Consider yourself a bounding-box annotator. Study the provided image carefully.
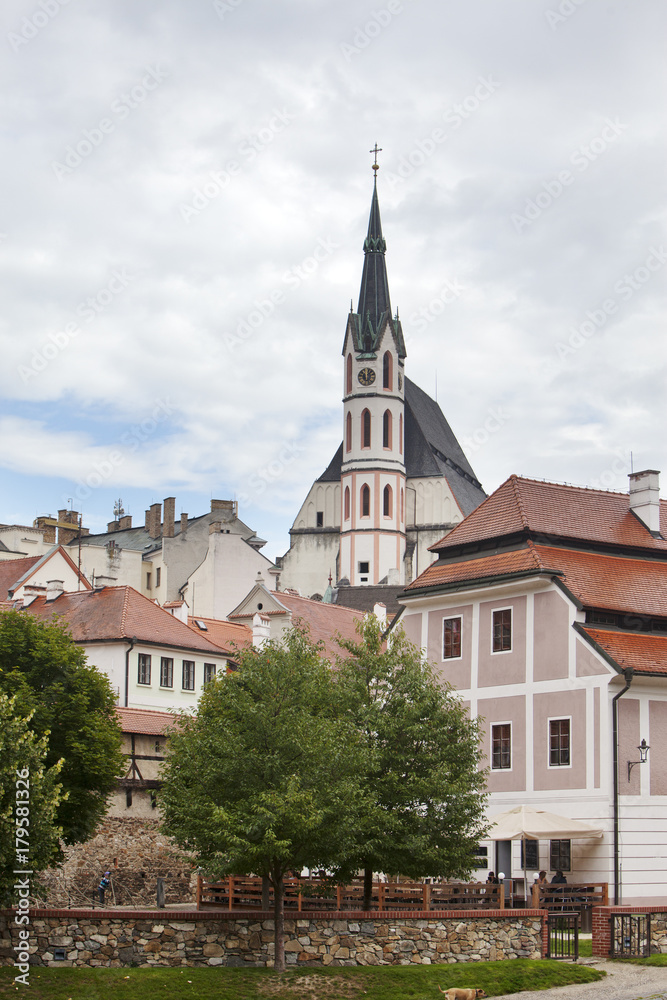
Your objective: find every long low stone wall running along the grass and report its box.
[0,910,544,967]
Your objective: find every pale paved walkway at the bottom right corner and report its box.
[515,961,667,1000]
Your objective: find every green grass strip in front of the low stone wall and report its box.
[0,956,604,1000]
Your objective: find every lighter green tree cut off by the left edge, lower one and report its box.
[0,692,63,906]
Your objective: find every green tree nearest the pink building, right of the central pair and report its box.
[336,615,486,908]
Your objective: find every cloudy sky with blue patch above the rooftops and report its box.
[0,0,667,558]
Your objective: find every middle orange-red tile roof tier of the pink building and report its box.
[406,540,667,617]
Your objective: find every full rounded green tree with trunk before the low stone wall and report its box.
[160,629,370,970]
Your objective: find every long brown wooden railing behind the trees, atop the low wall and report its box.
[197,875,505,912]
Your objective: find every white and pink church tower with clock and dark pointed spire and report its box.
[339,158,406,587]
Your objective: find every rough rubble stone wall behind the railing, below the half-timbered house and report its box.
[34,816,197,907]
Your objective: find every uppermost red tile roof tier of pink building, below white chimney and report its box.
[431,476,667,552]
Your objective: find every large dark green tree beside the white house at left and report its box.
[0,610,124,844]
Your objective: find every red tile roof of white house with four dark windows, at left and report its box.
[26,587,224,656]
